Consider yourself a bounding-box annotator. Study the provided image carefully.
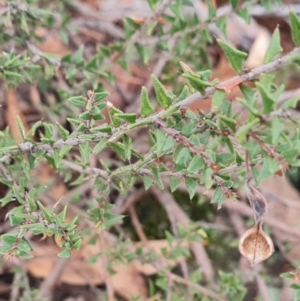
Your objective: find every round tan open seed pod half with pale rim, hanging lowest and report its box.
[239,222,274,265]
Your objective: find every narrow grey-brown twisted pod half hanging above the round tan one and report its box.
[246,181,267,223]
